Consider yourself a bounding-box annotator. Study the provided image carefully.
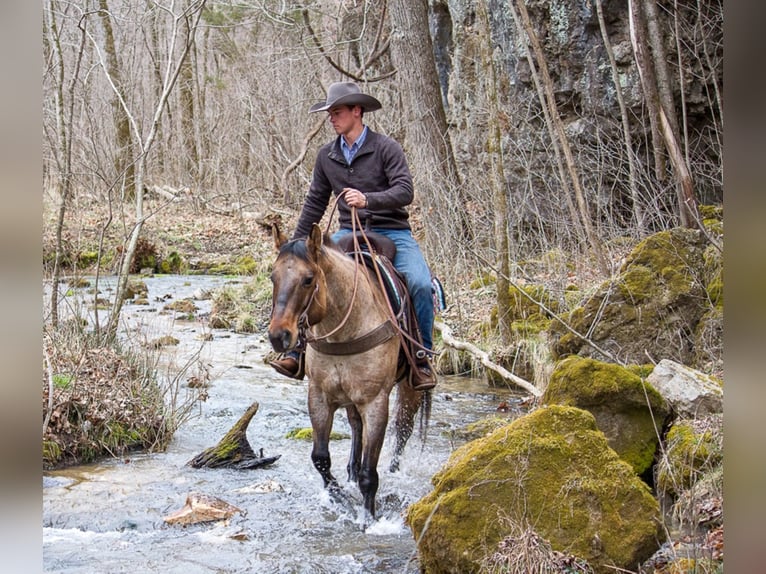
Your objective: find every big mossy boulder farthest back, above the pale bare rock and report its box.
[548,228,713,366]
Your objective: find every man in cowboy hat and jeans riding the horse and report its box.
[271,82,436,390]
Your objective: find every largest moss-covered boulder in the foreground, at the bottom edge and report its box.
[406,405,664,574]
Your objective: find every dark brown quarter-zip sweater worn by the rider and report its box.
[293,127,414,239]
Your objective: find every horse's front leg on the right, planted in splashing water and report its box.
[358,398,388,518]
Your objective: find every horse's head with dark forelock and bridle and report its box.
[269,225,327,353]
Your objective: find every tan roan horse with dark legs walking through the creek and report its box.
[268,224,431,519]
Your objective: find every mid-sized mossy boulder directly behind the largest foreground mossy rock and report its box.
[541,356,670,475]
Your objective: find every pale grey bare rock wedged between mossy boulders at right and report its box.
[647,359,723,417]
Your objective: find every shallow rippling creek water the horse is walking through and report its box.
[43,276,520,574]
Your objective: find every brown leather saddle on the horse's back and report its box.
[336,231,441,380]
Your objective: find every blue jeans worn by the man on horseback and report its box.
[332,227,434,351]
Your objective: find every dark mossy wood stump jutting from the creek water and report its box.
[186,402,282,470]
